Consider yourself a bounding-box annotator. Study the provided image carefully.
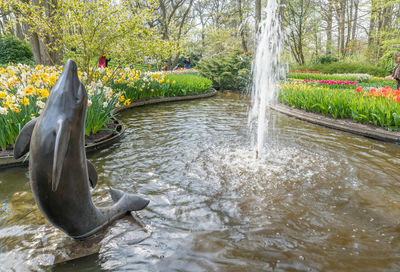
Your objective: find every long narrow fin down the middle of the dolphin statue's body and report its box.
[51,120,71,192]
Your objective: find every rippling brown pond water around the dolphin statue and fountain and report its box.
[0,94,400,271]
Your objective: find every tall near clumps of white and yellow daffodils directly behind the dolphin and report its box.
[0,65,124,150]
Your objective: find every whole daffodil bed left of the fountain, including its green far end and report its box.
[0,65,212,150]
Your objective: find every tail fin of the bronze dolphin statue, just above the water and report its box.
[110,188,150,212]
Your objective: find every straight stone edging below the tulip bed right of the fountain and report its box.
[270,104,400,144]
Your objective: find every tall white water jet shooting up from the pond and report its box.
[248,0,282,157]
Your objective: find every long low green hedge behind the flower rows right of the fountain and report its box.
[291,62,388,77]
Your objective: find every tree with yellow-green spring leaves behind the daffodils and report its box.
[3,0,175,78]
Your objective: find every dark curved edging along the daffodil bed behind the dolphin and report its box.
[0,90,217,169]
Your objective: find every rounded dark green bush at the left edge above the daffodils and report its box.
[0,36,33,64]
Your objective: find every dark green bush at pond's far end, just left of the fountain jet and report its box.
[197,51,252,91]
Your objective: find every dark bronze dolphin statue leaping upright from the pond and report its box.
[14,60,149,239]
